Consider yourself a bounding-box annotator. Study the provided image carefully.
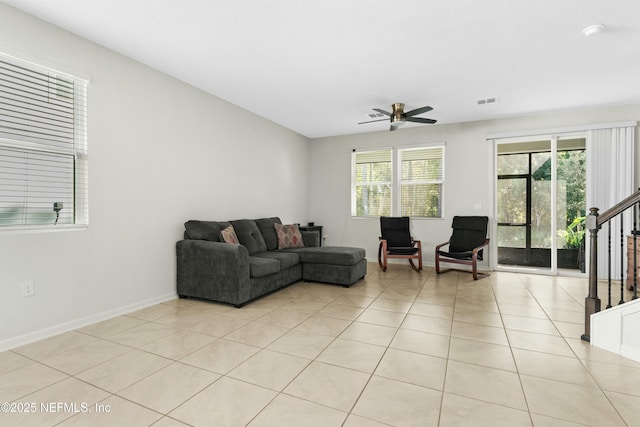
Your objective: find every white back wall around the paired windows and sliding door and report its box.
[309,105,640,268]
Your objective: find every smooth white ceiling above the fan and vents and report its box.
[5,0,640,138]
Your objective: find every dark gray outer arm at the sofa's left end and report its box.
[176,240,251,305]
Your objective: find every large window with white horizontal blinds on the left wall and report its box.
[0,55,88,229]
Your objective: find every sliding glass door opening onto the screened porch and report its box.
[496,137,586,272]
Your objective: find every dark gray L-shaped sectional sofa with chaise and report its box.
[176,217,367,307]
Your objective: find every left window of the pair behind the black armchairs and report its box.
[351,149,393,216]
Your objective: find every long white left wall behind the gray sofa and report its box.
[0,3,309,350]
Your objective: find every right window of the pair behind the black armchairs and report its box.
[399,146,444,218]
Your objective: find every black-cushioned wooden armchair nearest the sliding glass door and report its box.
[435,216,489,280]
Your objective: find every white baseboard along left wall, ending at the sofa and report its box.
[0,292,178,351]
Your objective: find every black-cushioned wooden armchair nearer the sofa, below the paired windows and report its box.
[378,216,422,272]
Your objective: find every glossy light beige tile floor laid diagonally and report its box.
[0,264,640,427]
